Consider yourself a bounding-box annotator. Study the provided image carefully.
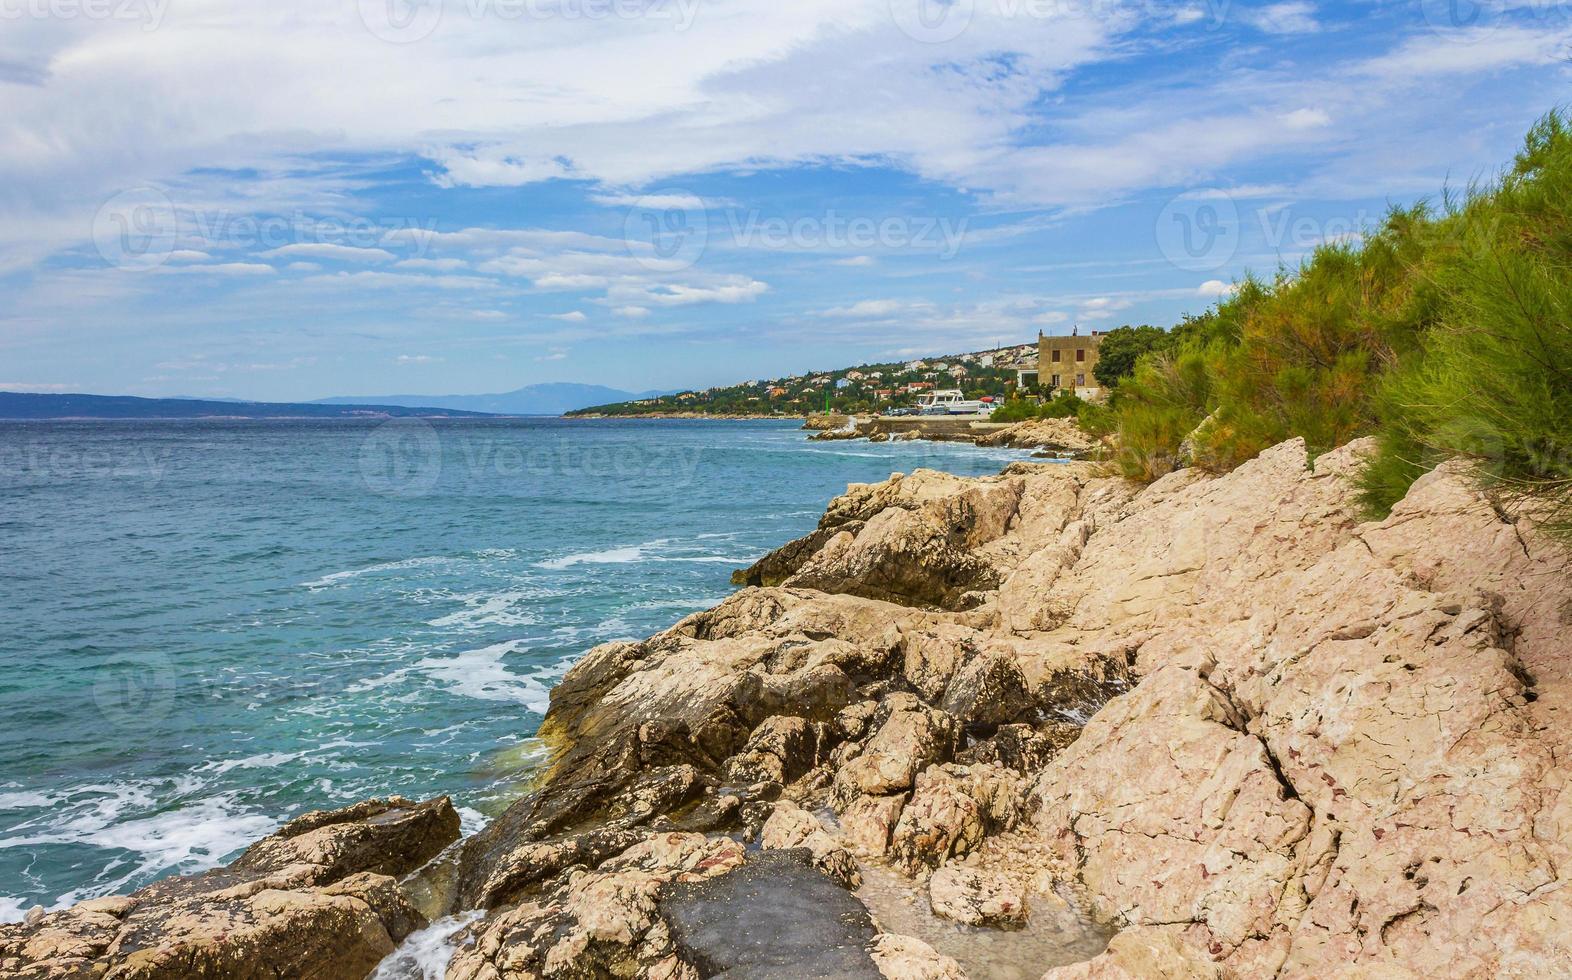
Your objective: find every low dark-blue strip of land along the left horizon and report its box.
[0,392,493,420]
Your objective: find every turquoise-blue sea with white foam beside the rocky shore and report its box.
[0,420,1023,922]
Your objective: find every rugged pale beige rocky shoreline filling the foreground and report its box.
[0,440,1572,980]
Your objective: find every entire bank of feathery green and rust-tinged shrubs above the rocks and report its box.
[1099,113,1572,547]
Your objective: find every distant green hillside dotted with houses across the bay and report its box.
[569,343,1038,417]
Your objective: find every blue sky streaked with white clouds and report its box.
[0,0,1572,400]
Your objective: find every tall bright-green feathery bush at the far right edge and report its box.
[1361,115,1572,536]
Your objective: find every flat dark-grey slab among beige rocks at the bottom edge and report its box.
[660,848,880,980]
